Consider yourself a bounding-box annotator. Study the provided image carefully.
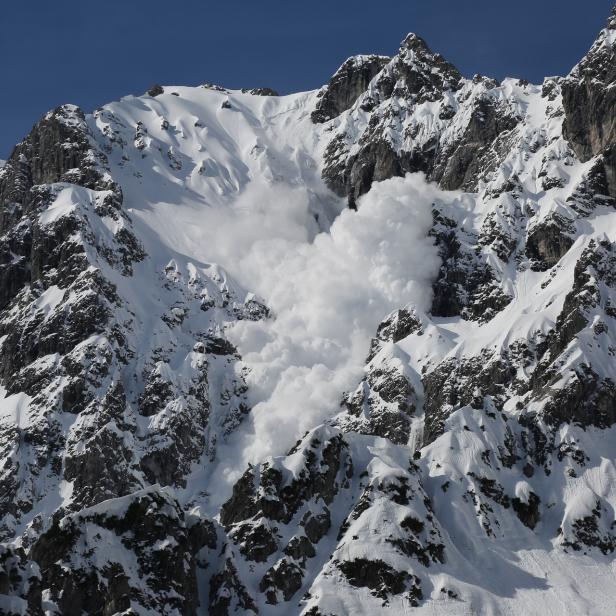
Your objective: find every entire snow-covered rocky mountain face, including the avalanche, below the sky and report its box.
[0,9,616,616]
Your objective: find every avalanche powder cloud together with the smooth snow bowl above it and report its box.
[88,87,442,496]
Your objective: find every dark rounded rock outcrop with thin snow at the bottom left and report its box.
[29,491,198,616]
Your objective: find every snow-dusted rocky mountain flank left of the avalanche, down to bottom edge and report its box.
[0,100,267,614]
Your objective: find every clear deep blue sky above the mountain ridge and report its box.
[0,0,616,158]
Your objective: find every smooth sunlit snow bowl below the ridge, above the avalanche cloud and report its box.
[94,86,340,237]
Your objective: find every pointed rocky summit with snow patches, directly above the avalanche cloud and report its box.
[319,34,520,206]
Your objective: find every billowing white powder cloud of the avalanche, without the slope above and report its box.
[210,175,443,496]
